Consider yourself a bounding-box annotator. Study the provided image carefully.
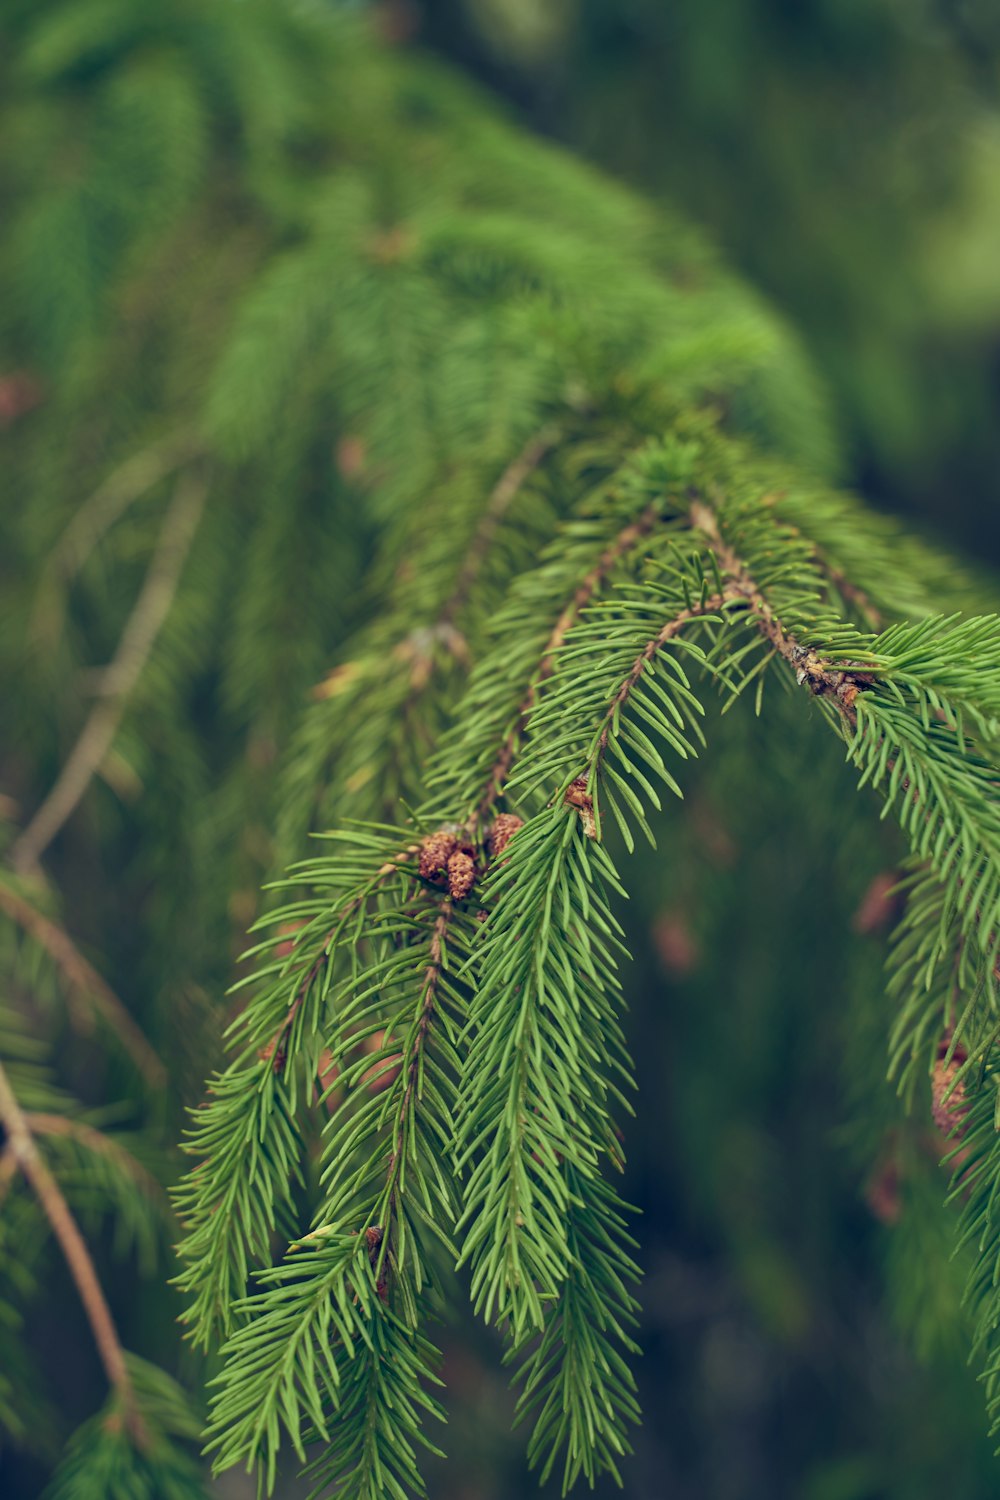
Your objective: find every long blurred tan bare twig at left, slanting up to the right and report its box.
[10,471,208,872]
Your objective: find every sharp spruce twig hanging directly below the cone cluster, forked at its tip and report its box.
[205,833,469,1497]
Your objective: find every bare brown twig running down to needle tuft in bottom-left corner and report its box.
[0,1064,145,1443]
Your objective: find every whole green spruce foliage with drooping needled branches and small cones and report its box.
[0,0,1000,1500]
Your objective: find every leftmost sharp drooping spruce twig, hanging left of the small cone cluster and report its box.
[174,827,417,1347]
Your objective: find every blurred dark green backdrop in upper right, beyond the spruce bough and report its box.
[424,0,1000,560]
